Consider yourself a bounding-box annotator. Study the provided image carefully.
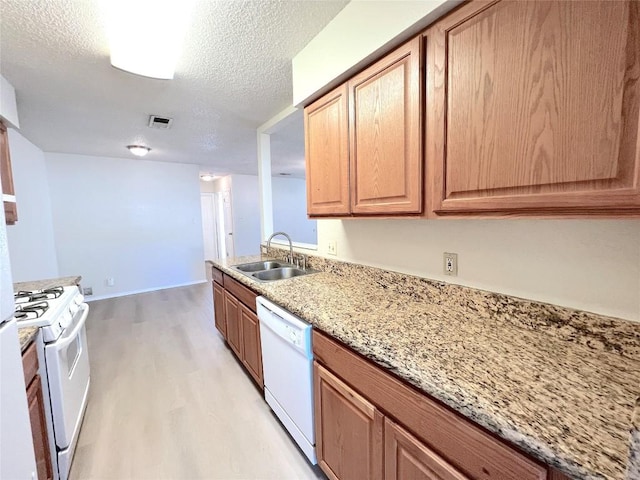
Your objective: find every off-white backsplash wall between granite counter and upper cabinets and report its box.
[318,219,640,321]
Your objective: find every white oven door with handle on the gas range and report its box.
[45,303,89,450]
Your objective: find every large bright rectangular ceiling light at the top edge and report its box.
[102,0,195,79]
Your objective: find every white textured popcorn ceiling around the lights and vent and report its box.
[0,0,347,176]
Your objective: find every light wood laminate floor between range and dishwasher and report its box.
[70,284,323,480]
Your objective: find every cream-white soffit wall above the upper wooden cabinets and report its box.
[292,0,460,105]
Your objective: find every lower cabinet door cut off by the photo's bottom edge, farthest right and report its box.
[384,418,469,480]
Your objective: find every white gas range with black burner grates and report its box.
[14,285,90,480]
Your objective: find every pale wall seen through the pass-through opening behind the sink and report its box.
[271,177,318,245]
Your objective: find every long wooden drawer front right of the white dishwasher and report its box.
[313,330,547,480]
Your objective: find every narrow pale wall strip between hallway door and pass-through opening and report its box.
[231,175,260,257]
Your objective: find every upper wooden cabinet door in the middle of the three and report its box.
[349,38,423,214]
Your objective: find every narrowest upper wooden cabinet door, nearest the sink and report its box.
[304,85,350,216]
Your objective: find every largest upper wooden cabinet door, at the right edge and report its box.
[426,1,640,214]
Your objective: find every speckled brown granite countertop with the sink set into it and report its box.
[212,255,640,479]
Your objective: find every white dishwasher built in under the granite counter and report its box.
[256,297,318,465]
